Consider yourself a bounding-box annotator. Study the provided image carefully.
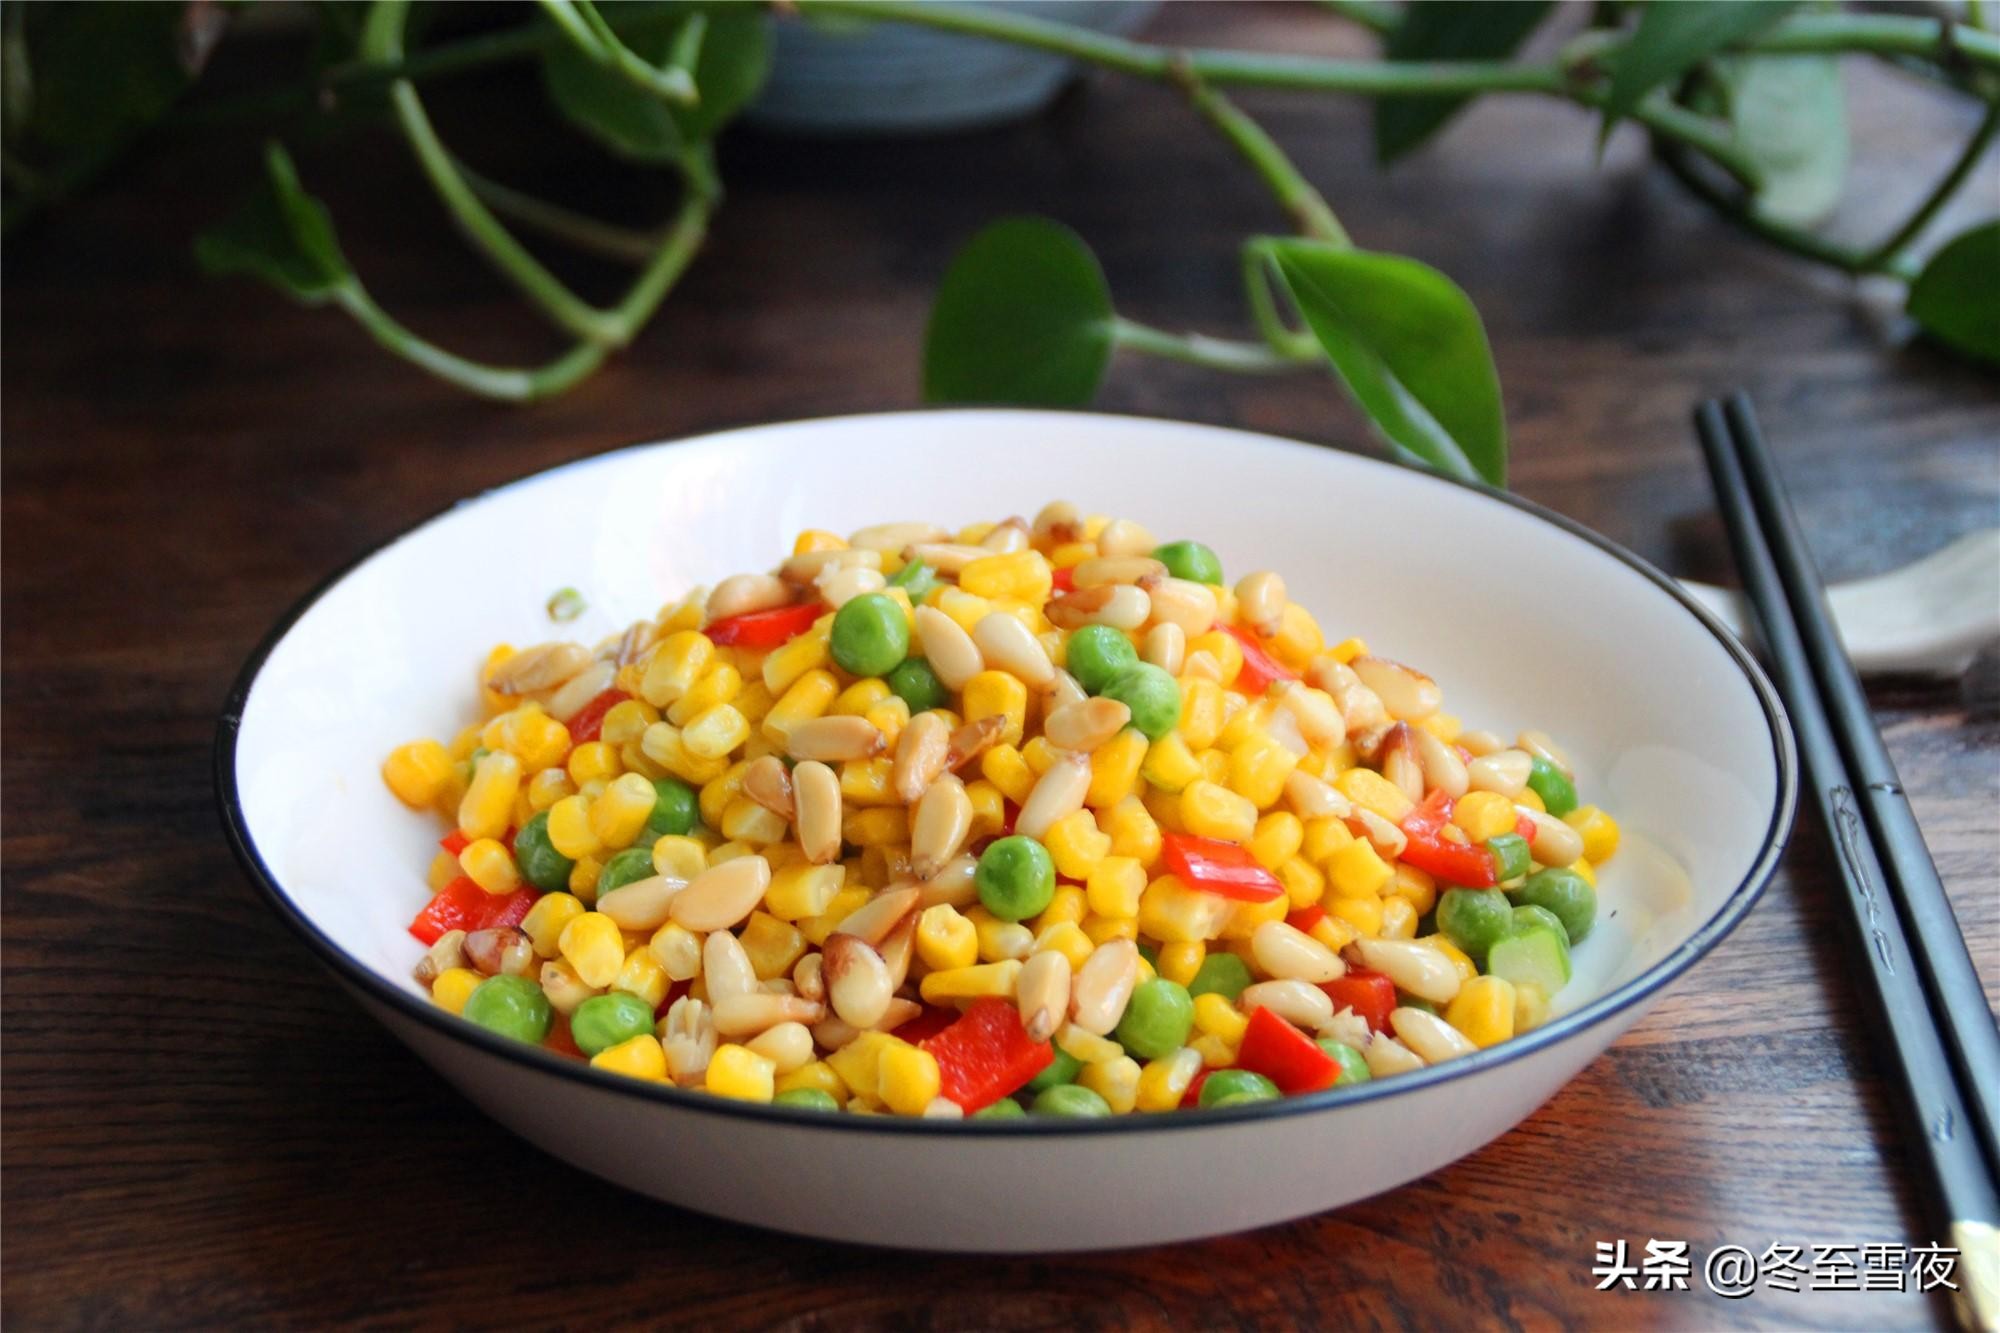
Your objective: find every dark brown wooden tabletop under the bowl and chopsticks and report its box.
[0,6,2000,1329]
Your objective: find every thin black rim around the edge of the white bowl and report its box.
[214,408,1798,1137]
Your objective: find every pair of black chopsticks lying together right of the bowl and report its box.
[1694,394,2000,1329]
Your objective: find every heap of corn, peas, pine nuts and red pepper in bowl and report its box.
[382,502,1618,1119]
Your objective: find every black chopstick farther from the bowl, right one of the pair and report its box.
[1724,392,2000,1173]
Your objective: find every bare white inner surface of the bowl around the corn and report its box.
[234,410,1786,1032]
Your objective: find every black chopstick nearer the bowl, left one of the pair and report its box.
[1694,402,2000,1327]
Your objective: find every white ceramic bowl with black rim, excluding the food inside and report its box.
[216,410,1794,1251]
